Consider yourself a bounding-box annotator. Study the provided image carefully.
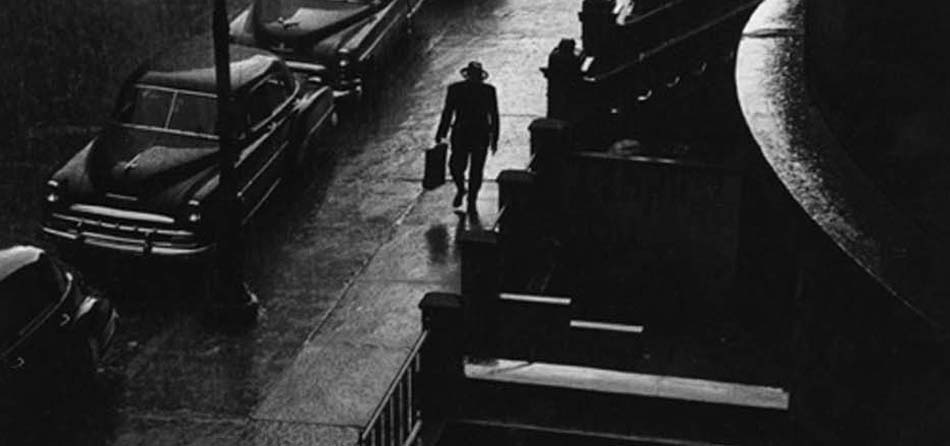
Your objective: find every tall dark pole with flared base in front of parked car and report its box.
[208,0,260,327]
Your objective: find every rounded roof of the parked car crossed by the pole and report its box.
[134,38,283,94]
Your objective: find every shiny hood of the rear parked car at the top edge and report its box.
[251,0,375,47]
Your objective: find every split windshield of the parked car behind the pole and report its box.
[119,85,218,137]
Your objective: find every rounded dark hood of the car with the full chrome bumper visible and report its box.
[55,129,218,215]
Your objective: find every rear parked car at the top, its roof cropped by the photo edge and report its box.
[231,0,423,98]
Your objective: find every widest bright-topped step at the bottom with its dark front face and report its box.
[459,359,790,445]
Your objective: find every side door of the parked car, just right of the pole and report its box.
[237,72,293,226]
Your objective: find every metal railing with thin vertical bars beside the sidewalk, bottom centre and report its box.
[359,331,428,446]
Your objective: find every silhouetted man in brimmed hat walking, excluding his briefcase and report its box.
[435,62,498,213]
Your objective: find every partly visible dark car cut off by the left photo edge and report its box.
[0,246,117,385]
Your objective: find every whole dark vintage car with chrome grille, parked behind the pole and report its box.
[43,41,336,260]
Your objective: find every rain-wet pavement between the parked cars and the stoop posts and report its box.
[0,0,580,445]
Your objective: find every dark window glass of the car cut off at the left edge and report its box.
[0,257,62,340]
